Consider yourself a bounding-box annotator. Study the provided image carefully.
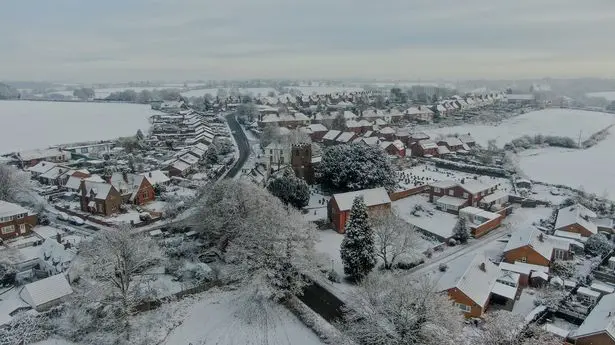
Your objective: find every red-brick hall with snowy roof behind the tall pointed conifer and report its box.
[327,187,391,234]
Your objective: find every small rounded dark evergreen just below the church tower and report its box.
[267,170,310,208]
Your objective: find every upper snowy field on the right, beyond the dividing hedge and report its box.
[426,109,615,146]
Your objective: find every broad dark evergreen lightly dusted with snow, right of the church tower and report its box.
[317,144,395,191]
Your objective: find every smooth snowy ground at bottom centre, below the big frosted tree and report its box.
[164,291,323,345]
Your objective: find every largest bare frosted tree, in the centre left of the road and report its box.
[191,180,319,299]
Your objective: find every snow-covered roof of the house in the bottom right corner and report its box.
[574,288,615,338]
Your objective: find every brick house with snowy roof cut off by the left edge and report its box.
[0,200,38,240]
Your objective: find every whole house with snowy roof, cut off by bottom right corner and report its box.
[570,294,615,345]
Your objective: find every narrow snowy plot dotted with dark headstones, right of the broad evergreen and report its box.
[398,164,513,193]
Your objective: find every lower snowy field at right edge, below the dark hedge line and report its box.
[519,129,615,200]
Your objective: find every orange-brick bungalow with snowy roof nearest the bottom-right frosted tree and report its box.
[437,254,502,318]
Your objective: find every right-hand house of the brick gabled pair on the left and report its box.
[109,172,156,205]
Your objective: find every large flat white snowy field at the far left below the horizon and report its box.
[0,101,156,153]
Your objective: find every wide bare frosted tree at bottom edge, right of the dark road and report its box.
[341,272,463,345]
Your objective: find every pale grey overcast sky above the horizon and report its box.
[0,0,615,82]
